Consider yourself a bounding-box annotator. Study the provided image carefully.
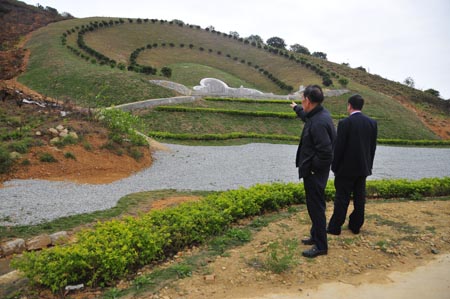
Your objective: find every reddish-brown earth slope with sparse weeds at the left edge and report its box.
[0,0,152,188]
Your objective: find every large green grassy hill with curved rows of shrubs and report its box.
[15,18,448,139]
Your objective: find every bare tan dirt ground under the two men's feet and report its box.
[151,201,450,299]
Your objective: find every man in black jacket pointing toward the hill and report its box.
[291,85,336,257]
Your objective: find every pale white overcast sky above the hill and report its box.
[25,0,450,99]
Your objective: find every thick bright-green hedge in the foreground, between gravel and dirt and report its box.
[12,177,450,292]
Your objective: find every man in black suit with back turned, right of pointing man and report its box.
[327,95,378,235]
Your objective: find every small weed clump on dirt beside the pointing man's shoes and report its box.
[264,239,298,274]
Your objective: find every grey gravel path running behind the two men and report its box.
[0,143,450,225]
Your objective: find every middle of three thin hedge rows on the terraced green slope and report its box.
[155,106,345,119]
